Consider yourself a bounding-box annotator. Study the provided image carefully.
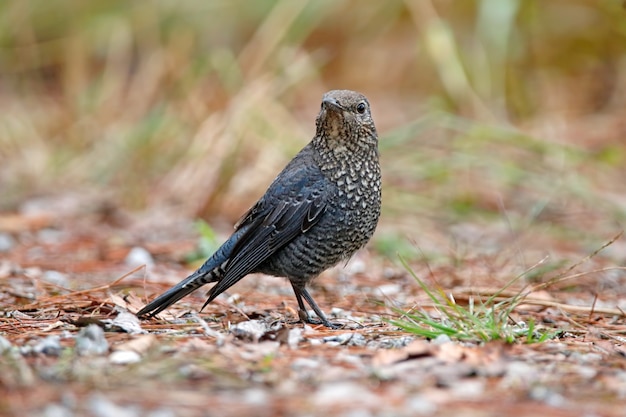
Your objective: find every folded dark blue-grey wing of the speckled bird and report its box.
[200,189,327,305]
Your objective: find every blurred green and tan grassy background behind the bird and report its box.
[0,0,626,270]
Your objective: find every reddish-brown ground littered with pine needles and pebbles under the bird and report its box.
[0,198,626,417]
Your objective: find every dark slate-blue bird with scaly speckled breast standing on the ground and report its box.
[137,90,382,329]
